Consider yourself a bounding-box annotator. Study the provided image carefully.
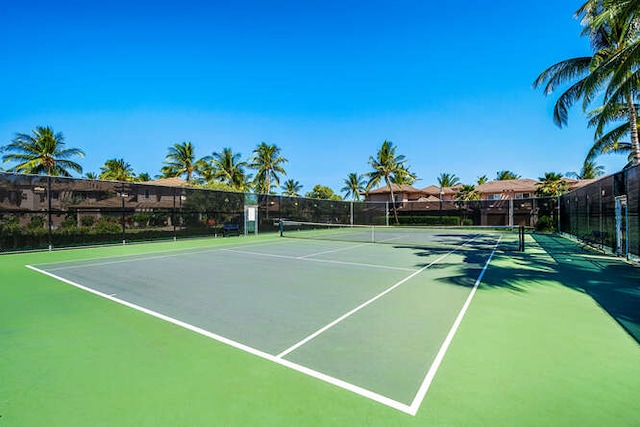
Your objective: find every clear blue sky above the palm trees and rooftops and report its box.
[0,0,625,192]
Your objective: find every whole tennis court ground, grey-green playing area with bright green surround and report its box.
[0,234,640,427]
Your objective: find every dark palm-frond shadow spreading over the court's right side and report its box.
[402,234,640,343]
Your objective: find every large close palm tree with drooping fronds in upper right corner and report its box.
[533,0,640,164]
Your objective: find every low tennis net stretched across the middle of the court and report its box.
[280,221,525,251]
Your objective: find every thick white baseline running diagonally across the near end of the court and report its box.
[26,265,410,414]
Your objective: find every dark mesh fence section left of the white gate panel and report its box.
[0,173,244,251]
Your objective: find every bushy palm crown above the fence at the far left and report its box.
[2,126,84,176]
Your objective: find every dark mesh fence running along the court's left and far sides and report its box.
[0,173,557,251]
